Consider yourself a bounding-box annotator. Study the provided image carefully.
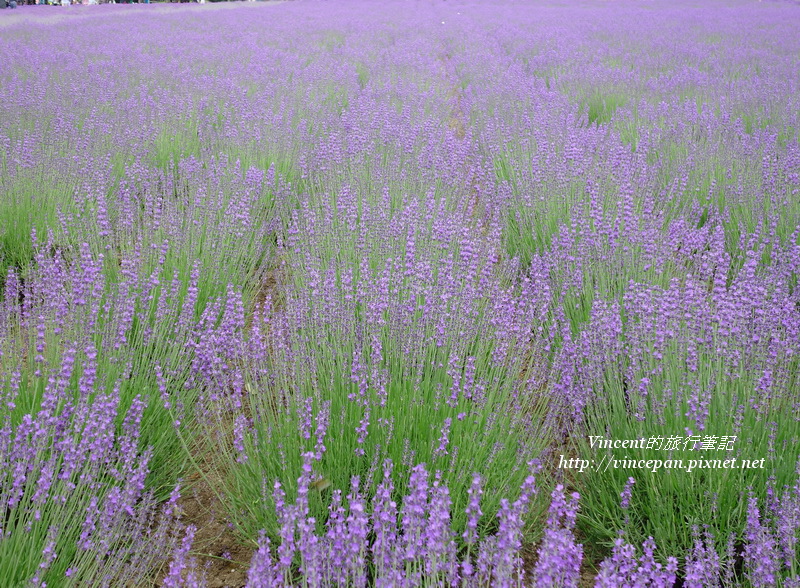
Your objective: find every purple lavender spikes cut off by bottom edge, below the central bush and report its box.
[247,460,536,587]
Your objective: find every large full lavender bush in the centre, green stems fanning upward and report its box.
[218,194,551,538]
